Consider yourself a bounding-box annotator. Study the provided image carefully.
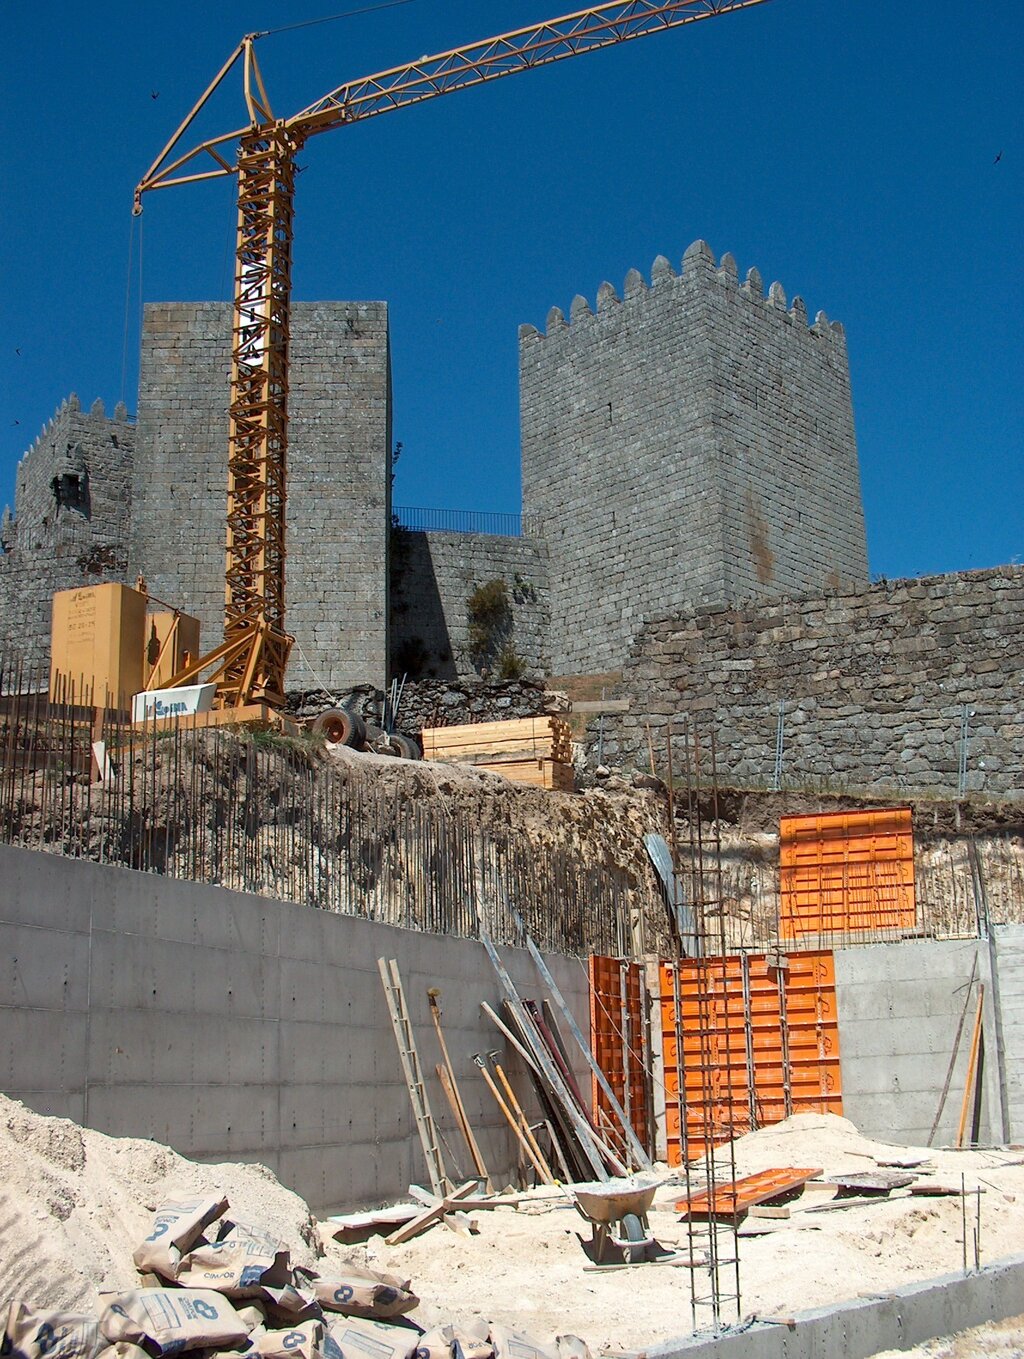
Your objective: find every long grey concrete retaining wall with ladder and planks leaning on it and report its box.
[0,845,589,1212]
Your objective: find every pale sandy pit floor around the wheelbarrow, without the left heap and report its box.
[361,1114,1024,1352]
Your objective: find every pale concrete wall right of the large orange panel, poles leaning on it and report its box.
[835,939,1001,1146]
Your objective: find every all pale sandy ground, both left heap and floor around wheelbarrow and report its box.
[7,1097,1024,1359]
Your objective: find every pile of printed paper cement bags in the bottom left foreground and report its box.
[0,1197,590,1359]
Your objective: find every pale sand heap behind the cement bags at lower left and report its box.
[0,1095,322,1311]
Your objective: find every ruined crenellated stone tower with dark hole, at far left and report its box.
[0,395,135,667]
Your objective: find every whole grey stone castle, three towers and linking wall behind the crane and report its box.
[0,242,868,690]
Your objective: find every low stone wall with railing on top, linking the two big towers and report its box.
[390,529,549,680]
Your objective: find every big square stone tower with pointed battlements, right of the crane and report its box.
[519,241,868,674]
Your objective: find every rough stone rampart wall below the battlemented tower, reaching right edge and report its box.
[604,567,1024,798]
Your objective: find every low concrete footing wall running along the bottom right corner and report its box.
[643,1256,1024,1359]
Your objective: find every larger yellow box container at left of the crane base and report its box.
[50,583,147,708]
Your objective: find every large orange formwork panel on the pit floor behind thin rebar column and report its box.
[660,950,843,1165]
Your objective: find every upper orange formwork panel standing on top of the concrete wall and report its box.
[779,807,917,939]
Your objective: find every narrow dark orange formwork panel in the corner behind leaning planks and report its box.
[587,954,650,1152]
